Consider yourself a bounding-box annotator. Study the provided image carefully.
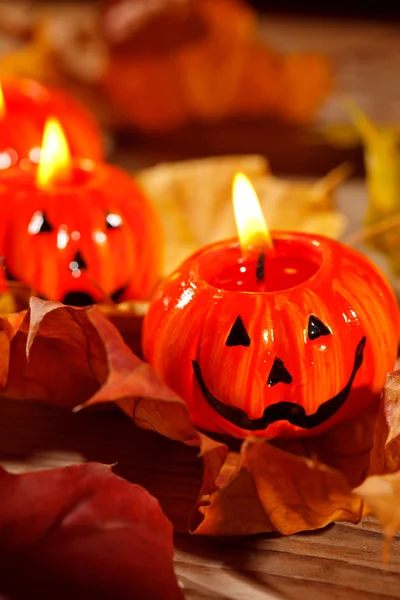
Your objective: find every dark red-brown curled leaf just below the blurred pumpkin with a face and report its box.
[3,298,107,408]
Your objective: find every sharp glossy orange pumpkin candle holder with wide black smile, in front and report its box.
[143,233,399,437]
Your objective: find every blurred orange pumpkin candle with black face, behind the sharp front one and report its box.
[0,159,163,303]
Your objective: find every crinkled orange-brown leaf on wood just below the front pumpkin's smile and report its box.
[191,443,361,535]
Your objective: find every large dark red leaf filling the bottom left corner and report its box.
[0,463,183,600]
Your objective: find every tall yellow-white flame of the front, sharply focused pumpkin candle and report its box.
[233,173,272,254]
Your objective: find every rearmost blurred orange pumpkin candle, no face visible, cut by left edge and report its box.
[0,79,104,169]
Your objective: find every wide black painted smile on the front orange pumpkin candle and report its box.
[192,337,367,431]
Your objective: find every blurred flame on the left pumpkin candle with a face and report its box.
[36,118,71,188]
